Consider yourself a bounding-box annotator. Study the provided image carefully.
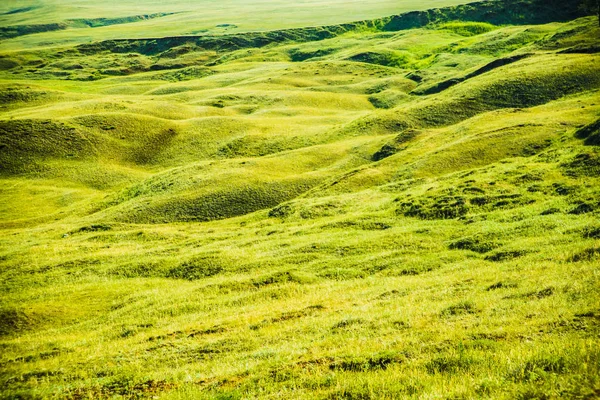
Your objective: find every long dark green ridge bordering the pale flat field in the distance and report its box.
[77,0,590,54]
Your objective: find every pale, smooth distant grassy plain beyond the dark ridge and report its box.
[0,0,469,51]
